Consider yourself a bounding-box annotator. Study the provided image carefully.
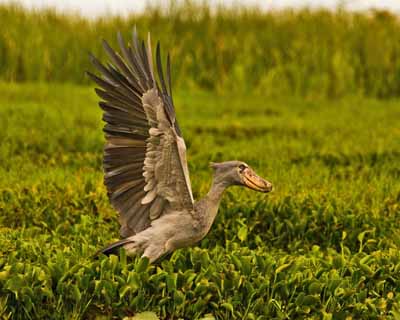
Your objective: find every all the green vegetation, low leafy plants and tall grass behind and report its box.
[0,3,400,320]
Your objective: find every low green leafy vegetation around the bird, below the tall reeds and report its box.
[0,83,400,319]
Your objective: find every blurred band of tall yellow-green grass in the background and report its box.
[0,2,400,98]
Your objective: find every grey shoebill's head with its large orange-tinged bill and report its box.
[210,161,272,193]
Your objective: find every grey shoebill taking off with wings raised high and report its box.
[87,27,272,263]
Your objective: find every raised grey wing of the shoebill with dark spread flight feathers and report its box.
[88,30,193,237]
